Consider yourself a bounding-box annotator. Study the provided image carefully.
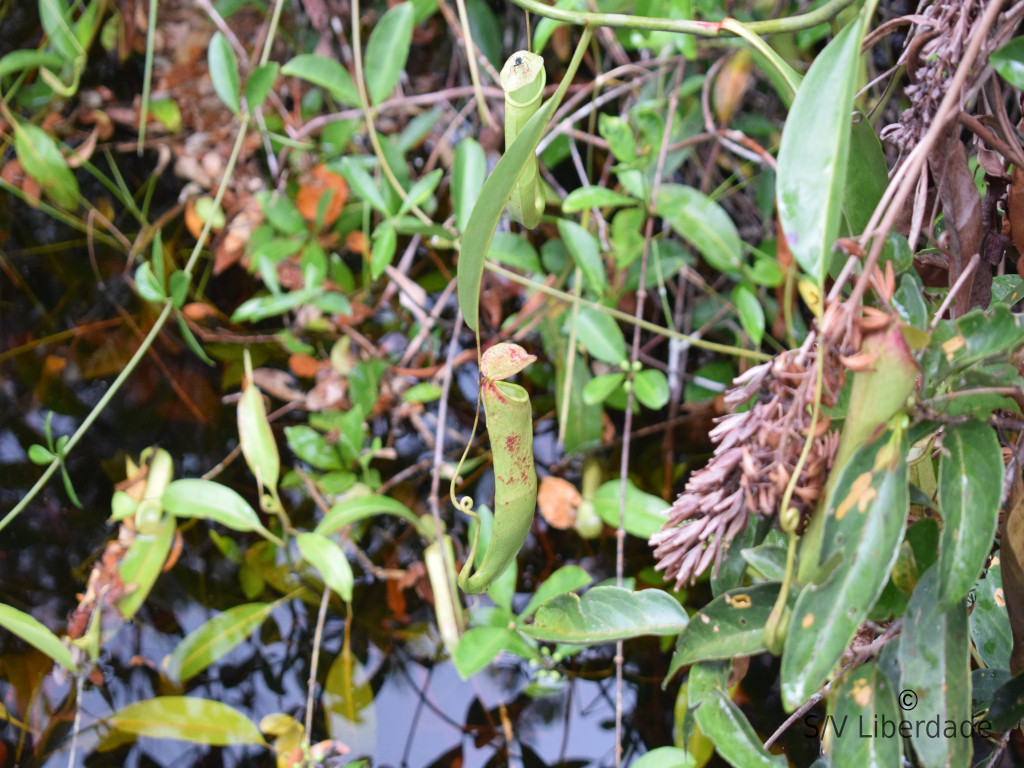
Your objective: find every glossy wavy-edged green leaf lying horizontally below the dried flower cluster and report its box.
[520,587,687,645]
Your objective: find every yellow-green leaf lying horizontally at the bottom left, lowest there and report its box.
[106,696,266,746]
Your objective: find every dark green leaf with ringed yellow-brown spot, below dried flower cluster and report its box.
[668,584,779,679]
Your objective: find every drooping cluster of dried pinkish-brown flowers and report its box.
[650,335,844,590]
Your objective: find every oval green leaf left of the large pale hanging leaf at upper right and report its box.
[656,184,742,275]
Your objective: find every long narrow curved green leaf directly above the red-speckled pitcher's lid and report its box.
[458,90,558,331]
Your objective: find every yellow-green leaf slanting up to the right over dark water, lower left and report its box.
[164,603,276,683]
